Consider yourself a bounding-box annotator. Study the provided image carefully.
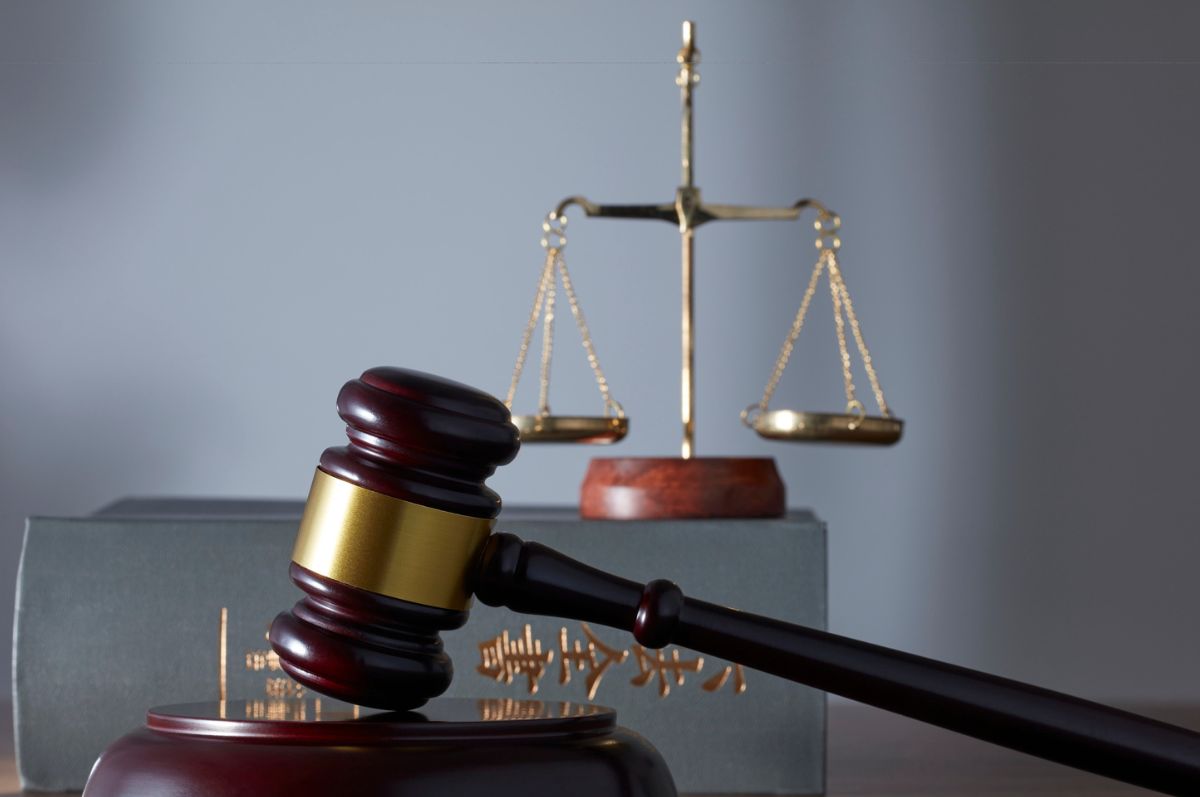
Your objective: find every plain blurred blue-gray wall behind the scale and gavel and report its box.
[0,0,1200,700]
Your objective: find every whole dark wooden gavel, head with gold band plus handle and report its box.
[270,367,1200,795]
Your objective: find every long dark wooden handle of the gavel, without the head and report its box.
[472,534,1200,795]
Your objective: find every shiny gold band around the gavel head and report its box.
[292,468,494,611]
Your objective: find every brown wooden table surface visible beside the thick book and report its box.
[0,703,1200,797]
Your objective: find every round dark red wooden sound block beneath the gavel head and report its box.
[84,697,676,797]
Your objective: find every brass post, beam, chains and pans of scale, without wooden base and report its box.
[505,22,904,459]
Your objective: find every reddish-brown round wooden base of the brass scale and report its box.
[580,456,786,520]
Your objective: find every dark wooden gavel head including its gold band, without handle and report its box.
[270,367,518,709]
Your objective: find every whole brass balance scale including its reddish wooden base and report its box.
[505,22,904,520]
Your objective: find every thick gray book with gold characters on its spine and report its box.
[13,499,826,795]
